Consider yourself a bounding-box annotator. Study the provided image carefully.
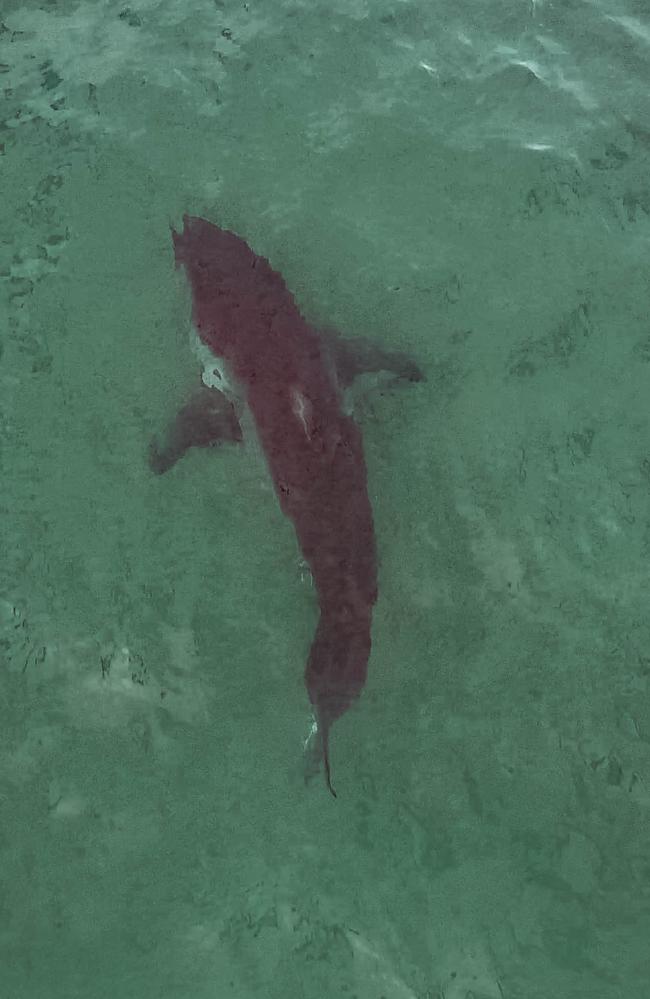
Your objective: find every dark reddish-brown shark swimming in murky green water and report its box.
[149,215,424,797]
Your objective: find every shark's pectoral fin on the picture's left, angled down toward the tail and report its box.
[149,386,242,475]
